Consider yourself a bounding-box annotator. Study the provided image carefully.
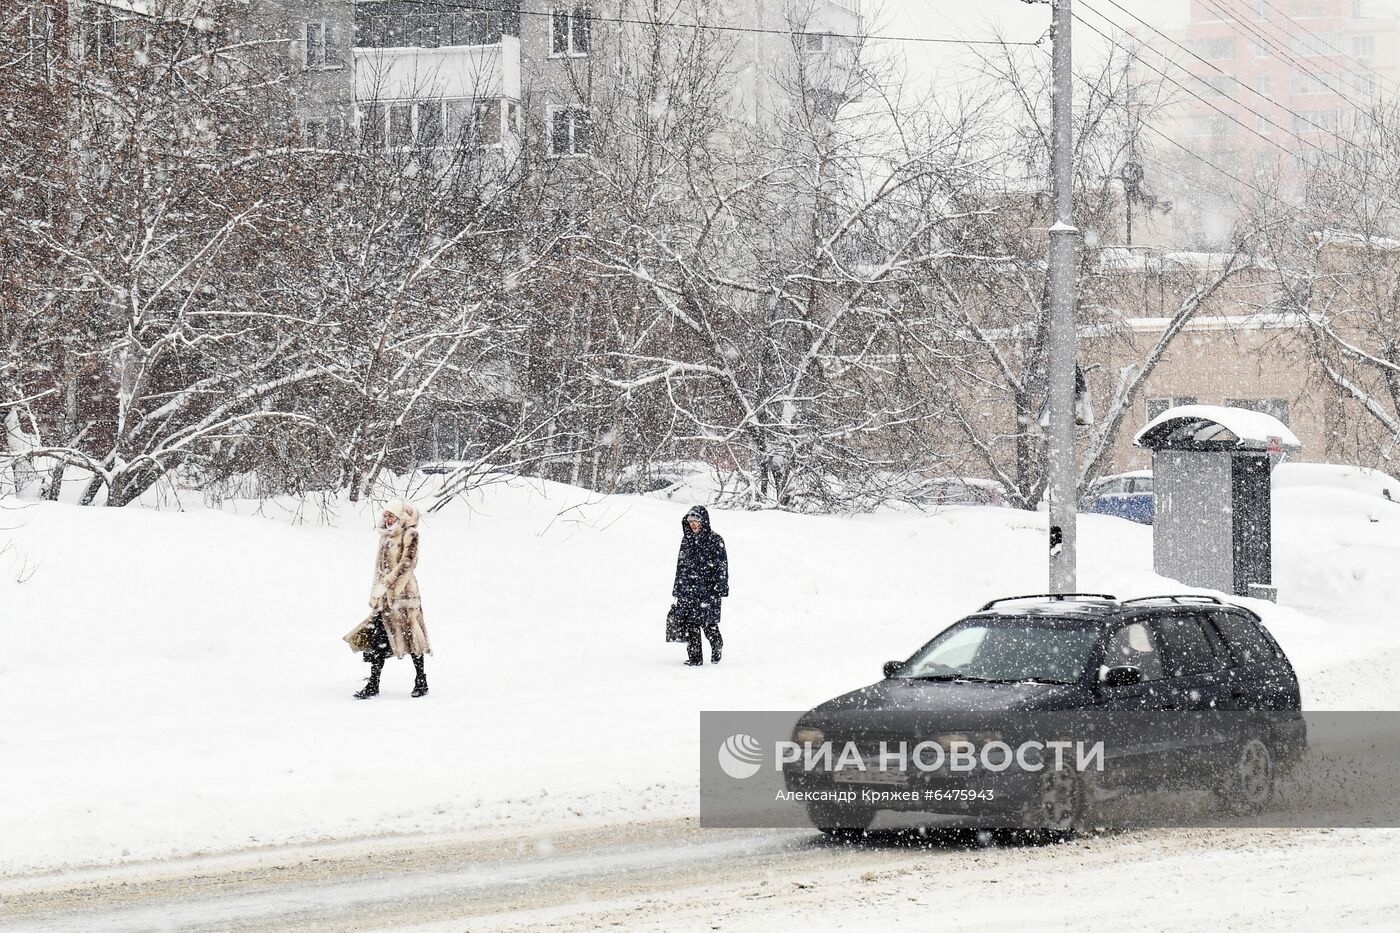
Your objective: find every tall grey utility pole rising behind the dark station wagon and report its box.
[1046,0,1079,593]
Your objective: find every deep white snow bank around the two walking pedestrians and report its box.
[0,483,1400,873]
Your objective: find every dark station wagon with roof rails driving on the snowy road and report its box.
[784,594,1306,832]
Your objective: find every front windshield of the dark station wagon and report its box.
[895,616,1098,684]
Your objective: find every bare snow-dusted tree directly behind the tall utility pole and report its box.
[937,36,1252,507]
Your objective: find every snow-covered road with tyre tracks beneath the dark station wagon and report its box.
[0,821,1400,933]
